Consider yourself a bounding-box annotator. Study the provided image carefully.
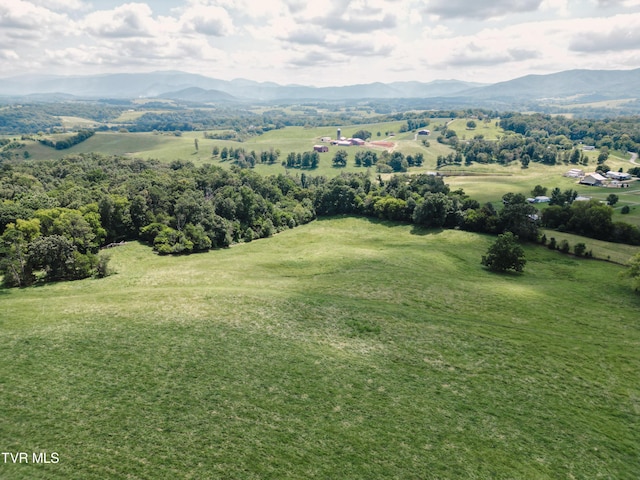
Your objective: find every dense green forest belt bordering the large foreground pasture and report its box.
[0,150,640,286]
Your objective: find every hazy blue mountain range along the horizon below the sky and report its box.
[0,68,640,103]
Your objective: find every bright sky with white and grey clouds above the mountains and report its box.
[0,0,640,87]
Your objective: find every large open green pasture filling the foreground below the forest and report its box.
[0,217,640,480]
